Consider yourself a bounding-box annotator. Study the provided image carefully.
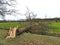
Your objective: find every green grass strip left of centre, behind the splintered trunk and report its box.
[0,22,28,28]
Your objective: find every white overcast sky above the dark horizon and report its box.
[0,0,60,19]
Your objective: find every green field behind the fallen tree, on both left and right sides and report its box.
[0,22,60,33]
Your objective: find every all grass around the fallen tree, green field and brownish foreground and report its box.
[0,22,60,45]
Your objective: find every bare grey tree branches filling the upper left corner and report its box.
[0,0,16,20]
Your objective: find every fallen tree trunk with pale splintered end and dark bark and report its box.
[6,26,31,39]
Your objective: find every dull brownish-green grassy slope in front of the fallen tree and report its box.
[0,30,60,45]
